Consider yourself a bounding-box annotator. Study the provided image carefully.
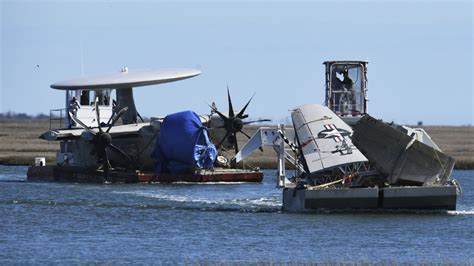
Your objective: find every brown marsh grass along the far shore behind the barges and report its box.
[0,119,474,169]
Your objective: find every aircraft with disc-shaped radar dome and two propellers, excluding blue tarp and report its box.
[40,67,268,179]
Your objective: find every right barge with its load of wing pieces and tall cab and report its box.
[236,61,459,212]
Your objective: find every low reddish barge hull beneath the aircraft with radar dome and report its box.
[27,166,263,183]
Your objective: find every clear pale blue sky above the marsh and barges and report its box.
[0,0,474,125]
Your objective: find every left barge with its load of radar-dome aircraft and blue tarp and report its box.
[27,67,263,183]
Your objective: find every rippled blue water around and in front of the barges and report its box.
[0,166,474,264]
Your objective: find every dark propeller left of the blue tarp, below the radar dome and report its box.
[69,97,131,180]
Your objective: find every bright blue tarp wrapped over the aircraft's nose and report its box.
[153,111,217,174]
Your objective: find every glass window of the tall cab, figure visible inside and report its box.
[330,64,364,116]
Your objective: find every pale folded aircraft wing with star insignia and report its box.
[291,104,367,173]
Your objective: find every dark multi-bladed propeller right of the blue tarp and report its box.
[209,86,271,154]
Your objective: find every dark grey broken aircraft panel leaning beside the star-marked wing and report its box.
[352,115,454,185]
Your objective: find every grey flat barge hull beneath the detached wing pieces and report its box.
[283,186,457,212]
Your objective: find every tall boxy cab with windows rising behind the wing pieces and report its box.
[323,61,368,125]
